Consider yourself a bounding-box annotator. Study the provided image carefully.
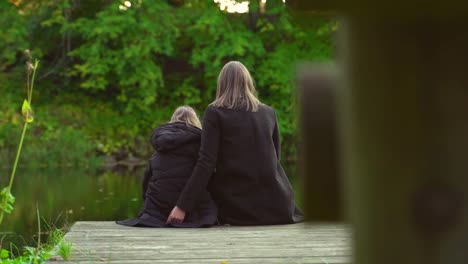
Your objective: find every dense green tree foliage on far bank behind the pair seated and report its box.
[0,0,338,163]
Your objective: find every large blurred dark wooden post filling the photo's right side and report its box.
[296,0,468,264]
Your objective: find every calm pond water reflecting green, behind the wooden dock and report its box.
[0,164,300,248]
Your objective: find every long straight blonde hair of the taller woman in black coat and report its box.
[211,61,260,112]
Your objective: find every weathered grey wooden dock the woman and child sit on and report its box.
[52,222,351,264]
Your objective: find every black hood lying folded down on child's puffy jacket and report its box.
[151,122,201,152]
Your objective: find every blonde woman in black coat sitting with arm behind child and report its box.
[167,61,303,225]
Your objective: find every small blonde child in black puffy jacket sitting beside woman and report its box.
[117,106,217,227]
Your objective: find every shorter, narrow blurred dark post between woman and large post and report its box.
[297,65,342,222]
